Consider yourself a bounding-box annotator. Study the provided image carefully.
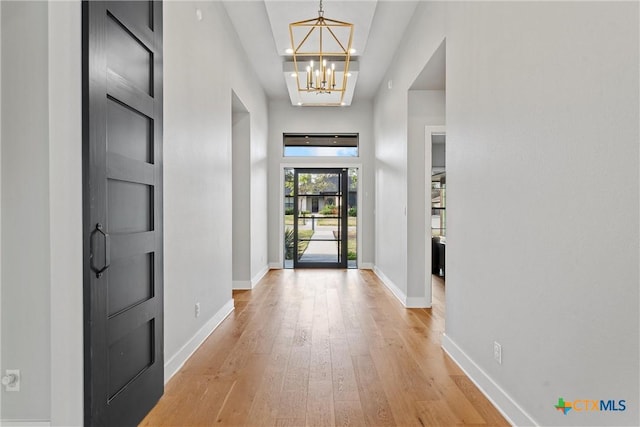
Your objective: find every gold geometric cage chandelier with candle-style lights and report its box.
[289,0,353,105]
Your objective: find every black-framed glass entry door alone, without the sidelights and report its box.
[293,168,349,268]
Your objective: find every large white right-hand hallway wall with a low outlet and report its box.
[375,2,640,425]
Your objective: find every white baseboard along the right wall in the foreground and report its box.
[442,334,539,426]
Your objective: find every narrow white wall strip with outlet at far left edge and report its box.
[1,2,51,420]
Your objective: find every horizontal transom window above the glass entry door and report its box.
[283,133,358,157]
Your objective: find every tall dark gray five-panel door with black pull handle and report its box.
[83,1,164,426]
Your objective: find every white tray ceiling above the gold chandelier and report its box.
[223,0,430,106]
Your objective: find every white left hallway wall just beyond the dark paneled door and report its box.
[164,1,268,375]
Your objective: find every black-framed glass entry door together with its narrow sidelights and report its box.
[284,167,358,268]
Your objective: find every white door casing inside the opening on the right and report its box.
[424,126,447,307]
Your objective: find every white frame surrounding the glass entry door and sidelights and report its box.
[278,162,362,269]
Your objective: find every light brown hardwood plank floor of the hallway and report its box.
[141,270,508,427]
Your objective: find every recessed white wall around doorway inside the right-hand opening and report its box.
[406,90,445,307]
